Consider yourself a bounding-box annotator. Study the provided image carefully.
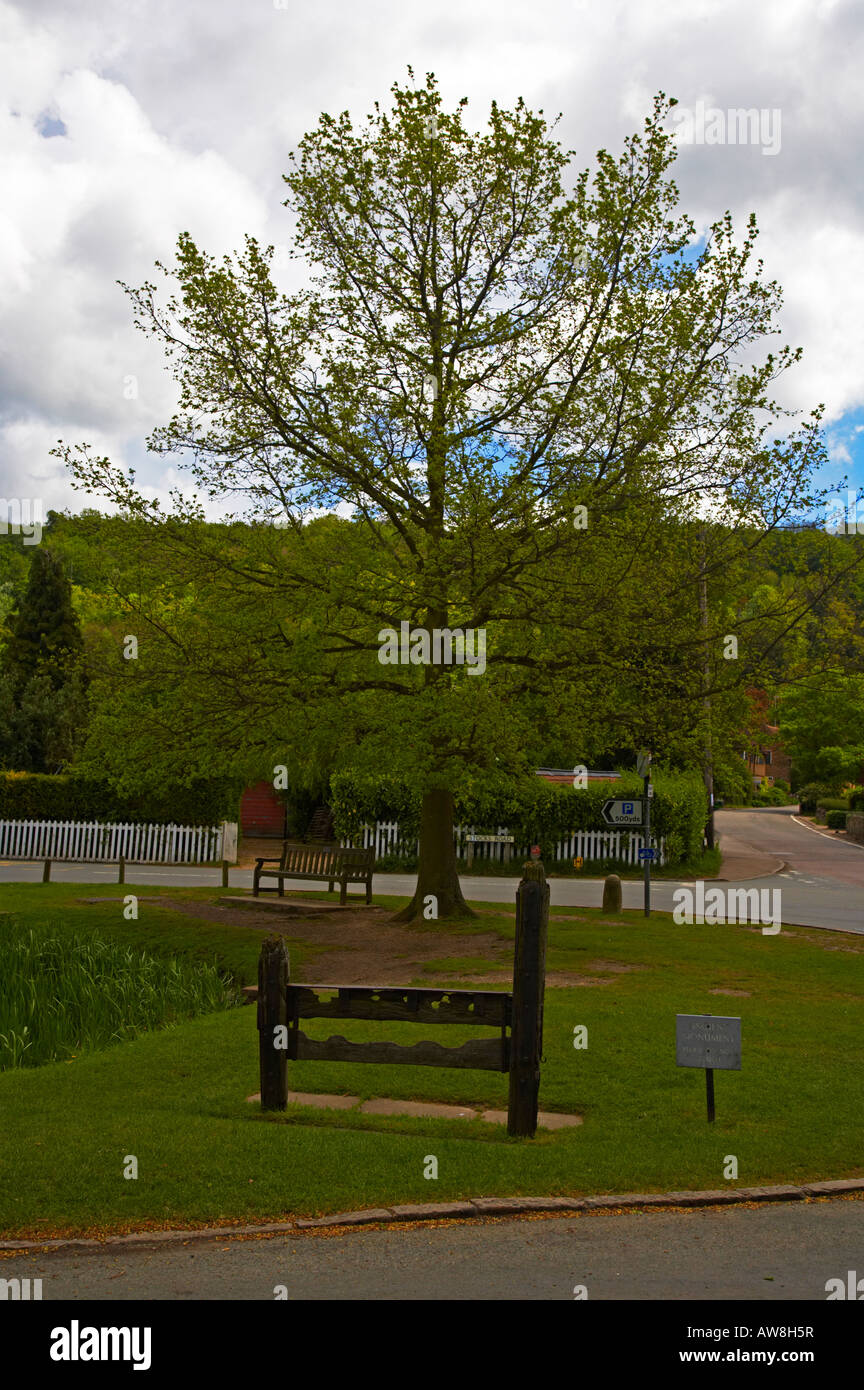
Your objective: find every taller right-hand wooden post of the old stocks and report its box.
[507,860,549,1138]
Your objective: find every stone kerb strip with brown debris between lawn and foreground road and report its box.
[0,1177,864,1254]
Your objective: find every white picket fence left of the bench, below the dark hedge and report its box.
[0,820,231,865]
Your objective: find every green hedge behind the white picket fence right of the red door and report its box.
[331,770,708,863]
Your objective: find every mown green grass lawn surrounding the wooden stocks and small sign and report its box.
[0,884,864,1236]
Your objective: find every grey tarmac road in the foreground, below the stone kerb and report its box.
[6,1200,864,1301]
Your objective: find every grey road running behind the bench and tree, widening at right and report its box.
[0,808,864,934]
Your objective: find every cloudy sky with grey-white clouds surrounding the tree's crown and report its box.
[0,0,864,522]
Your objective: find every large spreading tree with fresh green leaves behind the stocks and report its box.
[58,76,838,919]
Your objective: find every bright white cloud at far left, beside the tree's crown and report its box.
[0,10,267,505]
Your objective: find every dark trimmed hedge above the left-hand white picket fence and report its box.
[0,773,242,826]
